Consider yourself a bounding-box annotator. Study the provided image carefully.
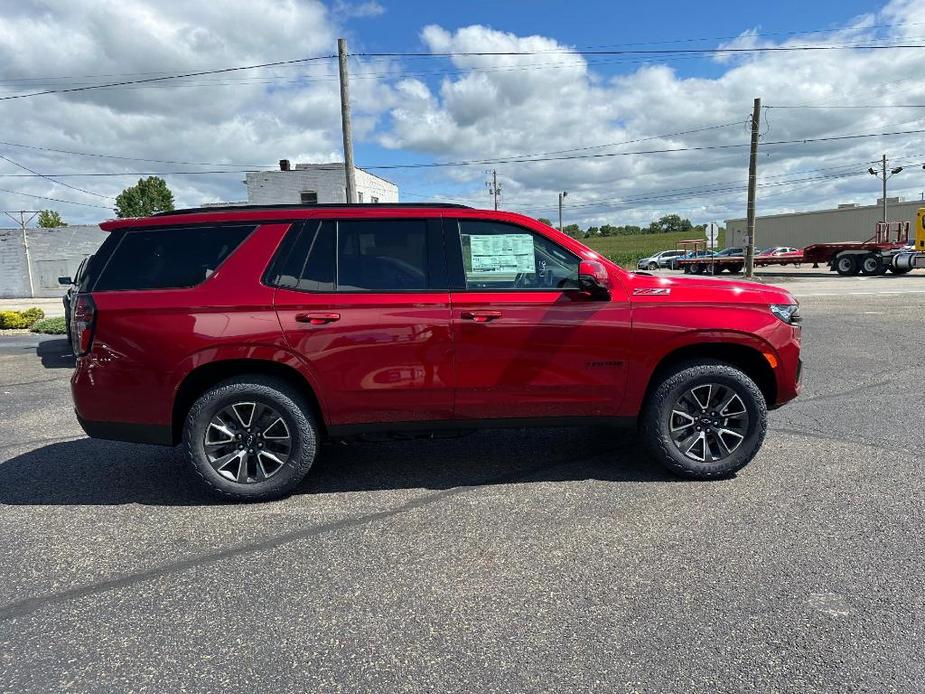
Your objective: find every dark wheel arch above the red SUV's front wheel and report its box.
[642,342,777,409]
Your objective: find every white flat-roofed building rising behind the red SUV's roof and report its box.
[244,159,398,205]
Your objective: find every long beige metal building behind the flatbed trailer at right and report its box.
[726,198,925,248]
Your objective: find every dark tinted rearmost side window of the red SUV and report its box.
[93,224,256,291]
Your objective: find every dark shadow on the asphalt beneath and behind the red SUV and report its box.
[0,428,680,506]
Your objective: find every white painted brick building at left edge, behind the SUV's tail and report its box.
[0,224,106,298]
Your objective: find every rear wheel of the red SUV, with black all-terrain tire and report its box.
[183,375,318,501]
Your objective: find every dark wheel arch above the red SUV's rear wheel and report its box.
[171,358,326,444]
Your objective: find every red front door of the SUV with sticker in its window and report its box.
[445,219,630,419]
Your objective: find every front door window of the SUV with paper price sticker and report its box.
[459,220,580,290]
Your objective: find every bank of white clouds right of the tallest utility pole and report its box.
[380,1,925,224]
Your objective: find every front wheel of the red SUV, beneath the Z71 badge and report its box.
[640,360,768,480]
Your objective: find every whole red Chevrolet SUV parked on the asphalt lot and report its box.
[71,205,801,500]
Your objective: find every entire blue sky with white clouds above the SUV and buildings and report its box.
[0,0,925,226]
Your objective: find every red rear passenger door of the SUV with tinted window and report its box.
[268,218,453,426]
